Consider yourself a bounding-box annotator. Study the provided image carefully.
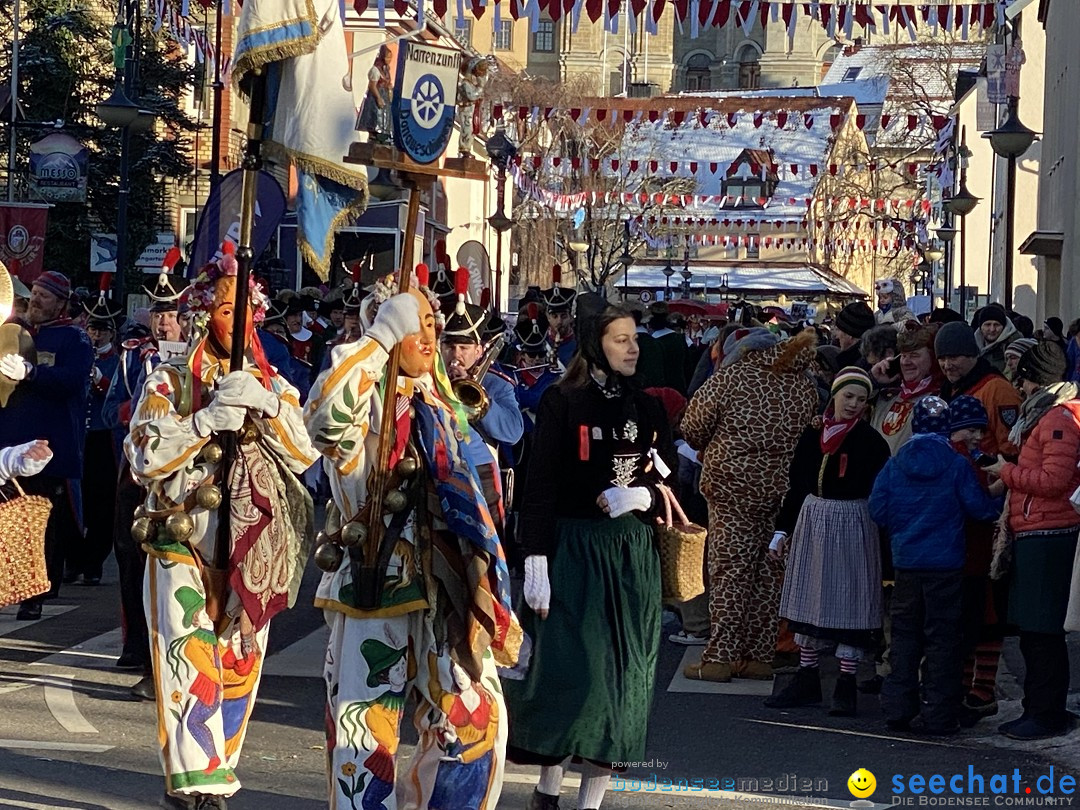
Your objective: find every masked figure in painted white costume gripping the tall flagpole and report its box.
[124,255,315,810]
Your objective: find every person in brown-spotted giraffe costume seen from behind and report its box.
[681,329,818,680]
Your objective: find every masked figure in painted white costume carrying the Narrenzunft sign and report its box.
[305,266,519,810]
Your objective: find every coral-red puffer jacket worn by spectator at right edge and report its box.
[1001,400,1080,531]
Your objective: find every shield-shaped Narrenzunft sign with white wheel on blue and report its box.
[390,42,461,163]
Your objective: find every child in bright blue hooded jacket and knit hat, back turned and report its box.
[869,396,1003,734]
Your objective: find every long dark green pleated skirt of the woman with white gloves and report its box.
[503,515,661,762]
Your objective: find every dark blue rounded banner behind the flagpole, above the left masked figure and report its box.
[187,168,285,279]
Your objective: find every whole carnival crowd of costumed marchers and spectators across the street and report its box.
[6,260,1080,810]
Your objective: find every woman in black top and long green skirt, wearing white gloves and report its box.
[504,294,675,810]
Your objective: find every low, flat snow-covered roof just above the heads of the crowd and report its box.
[626,262,868,298]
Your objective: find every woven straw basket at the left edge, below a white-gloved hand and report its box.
[0,478,53,606]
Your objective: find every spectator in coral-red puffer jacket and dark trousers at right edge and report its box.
[987,340,1080,740]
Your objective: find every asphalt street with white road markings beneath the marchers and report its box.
[0,557,1080,810]
